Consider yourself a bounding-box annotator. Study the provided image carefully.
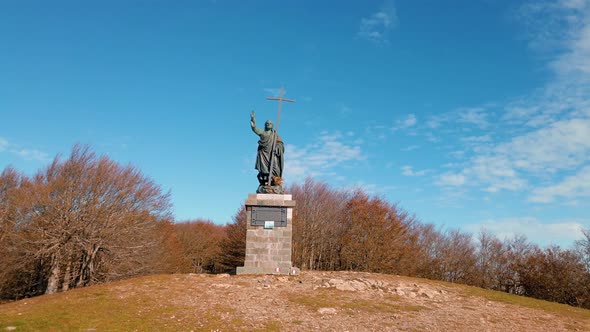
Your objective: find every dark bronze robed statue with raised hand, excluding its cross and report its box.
[250,112,285,194]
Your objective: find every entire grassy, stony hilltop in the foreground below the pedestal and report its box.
[0,272,590,331]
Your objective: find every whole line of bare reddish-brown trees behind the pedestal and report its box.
[0,145,590,308]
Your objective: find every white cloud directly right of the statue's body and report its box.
[284,132,366,181]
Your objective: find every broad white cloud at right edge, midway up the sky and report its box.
[439,115,590,195]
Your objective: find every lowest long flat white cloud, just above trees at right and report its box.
[463,217,590,246]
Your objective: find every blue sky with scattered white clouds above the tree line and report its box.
[0,0,590,246]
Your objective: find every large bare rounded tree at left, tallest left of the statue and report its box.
[13,145,170,294]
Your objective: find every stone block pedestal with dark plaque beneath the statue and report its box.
[236,194,299,274]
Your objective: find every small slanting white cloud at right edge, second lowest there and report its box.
[529,166,590,203]
